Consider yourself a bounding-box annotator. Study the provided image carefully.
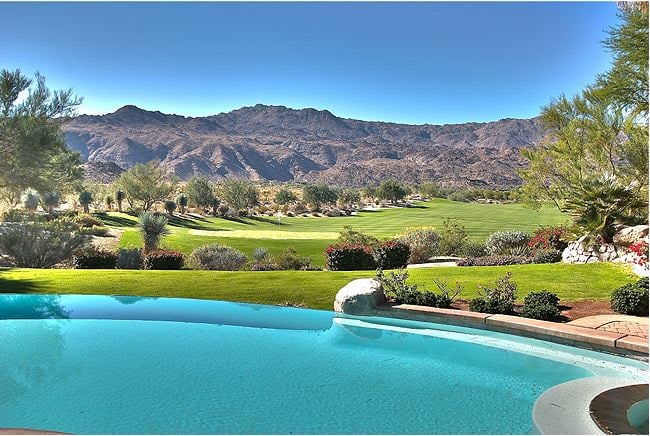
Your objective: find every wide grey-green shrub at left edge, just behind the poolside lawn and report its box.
[0,220,87,268]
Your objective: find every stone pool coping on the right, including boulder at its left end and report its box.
[334,279,648,361]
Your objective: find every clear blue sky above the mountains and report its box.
[0,3,617,124]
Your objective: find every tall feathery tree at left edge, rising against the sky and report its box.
[0,69,83,206]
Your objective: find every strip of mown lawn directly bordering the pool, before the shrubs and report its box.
[0,264,635,310]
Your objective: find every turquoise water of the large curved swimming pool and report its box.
[0,295,646,434]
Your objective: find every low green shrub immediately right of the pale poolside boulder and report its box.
[375,268,462,308]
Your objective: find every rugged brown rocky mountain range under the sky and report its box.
[64,105,542,188]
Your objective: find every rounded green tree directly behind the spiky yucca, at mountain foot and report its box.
[116,162,176,211]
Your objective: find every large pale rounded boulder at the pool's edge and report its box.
[334,279,386,315]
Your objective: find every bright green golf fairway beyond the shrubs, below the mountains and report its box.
[112,199,567,265]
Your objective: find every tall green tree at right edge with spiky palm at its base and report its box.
[519,7,648,241]
